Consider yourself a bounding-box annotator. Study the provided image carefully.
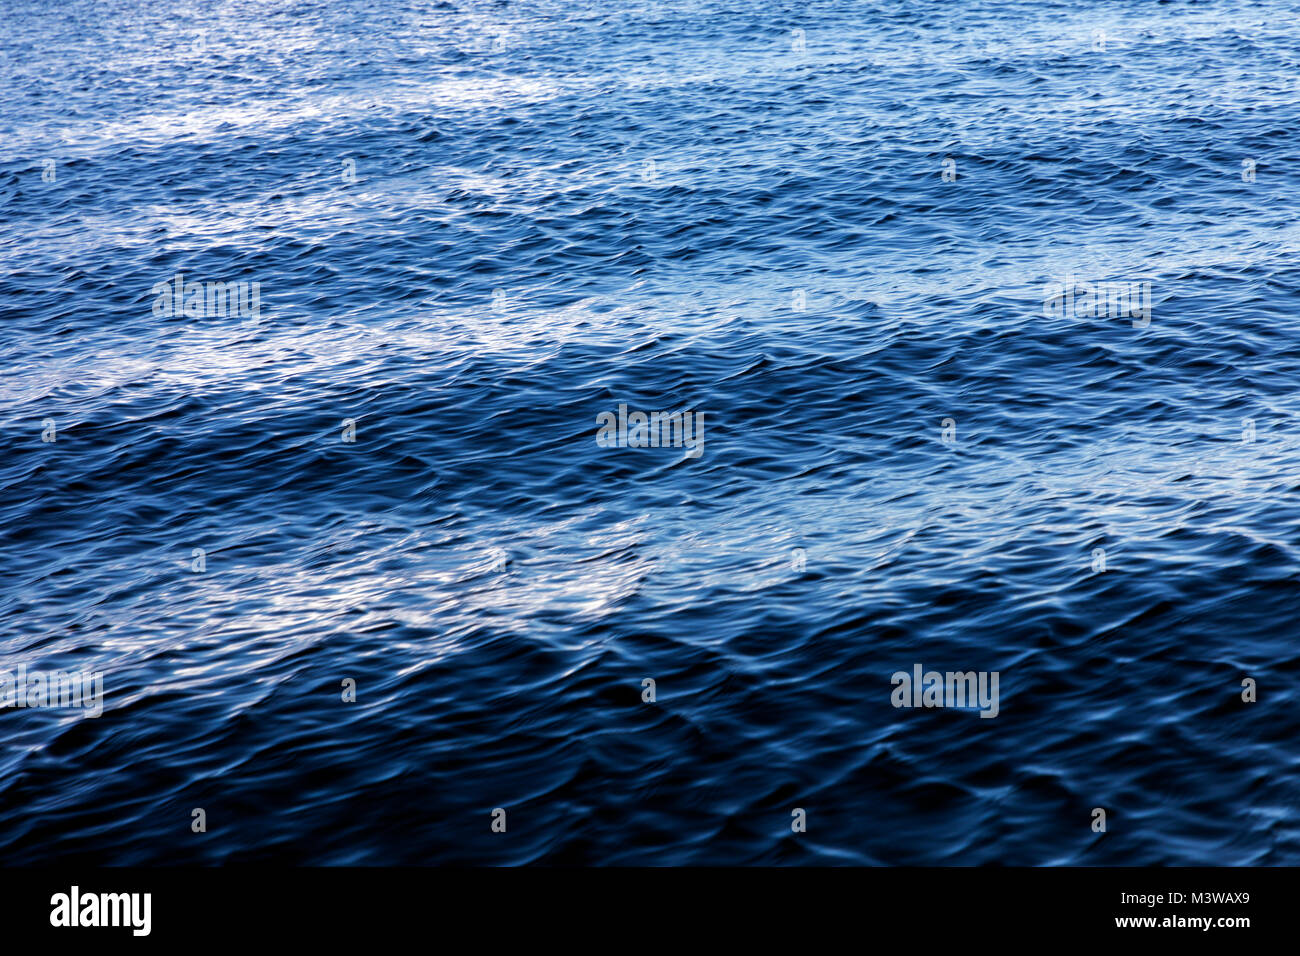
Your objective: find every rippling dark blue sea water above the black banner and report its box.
[0,0,1300,865]
